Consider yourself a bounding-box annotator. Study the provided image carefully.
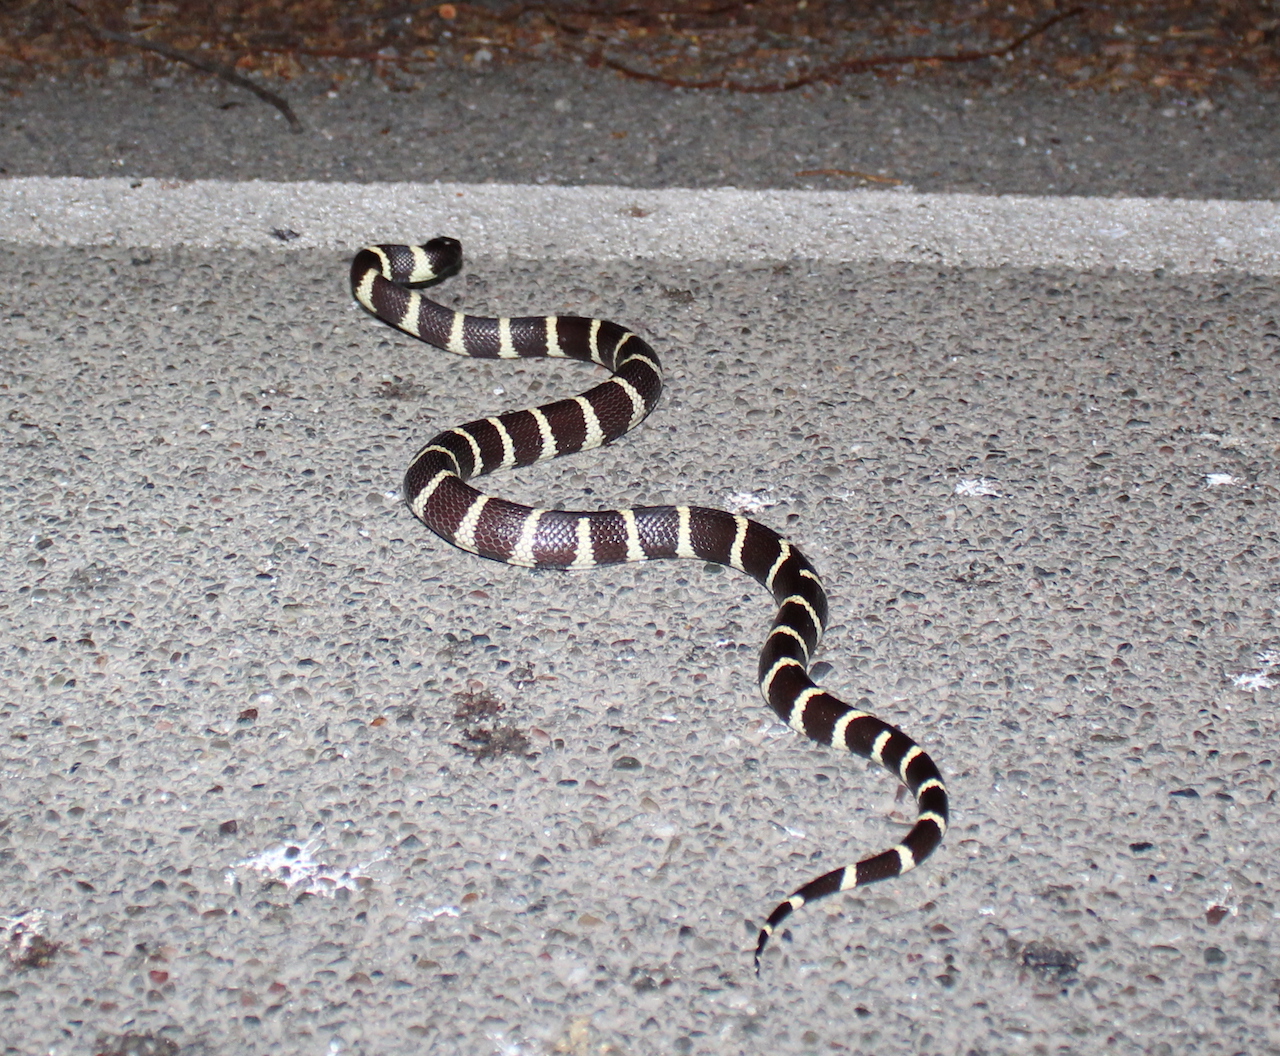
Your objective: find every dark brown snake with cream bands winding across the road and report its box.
[351,238,947,970]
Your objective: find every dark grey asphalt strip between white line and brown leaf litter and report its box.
[0,63,1280,200]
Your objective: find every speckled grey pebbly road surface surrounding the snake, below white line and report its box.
[0,247,1280,1056]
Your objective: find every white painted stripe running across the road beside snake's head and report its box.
[0,177,1280,275]
